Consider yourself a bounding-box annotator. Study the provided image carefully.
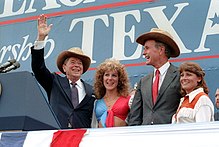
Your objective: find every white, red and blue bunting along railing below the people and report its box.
[0,122,219,147]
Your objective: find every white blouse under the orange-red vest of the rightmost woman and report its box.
[172,88,214,123]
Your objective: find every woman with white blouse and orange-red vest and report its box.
[172,62,214,123]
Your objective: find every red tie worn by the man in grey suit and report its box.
[152,69,160,104]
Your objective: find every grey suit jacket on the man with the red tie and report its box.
[128,64,181,126]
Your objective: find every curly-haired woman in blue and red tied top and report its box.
[92,59,130,128]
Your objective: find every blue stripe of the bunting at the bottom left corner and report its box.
[0,132,27,147]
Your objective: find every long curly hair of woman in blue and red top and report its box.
[94,59,130,99]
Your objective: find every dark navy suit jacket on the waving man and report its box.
[31,47,95,129]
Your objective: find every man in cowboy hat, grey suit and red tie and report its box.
[128,28,181,126]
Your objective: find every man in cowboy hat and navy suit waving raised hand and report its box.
[31,15,95,129]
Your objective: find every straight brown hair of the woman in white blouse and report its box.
[179,62,209,96]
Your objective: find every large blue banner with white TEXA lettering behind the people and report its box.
[0,0,219,98]
